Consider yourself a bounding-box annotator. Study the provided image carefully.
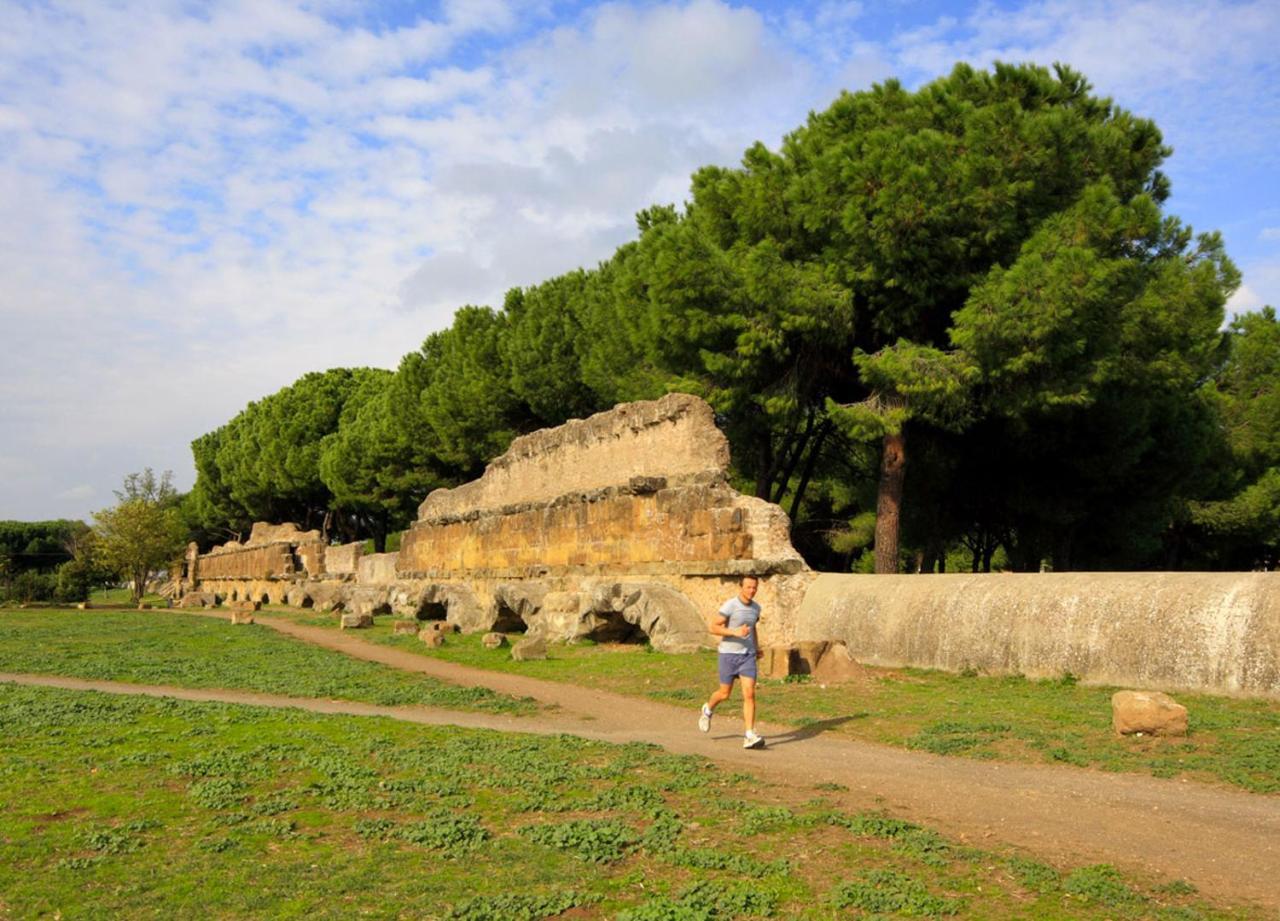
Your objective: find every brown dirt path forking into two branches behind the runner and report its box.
[10,614,1280,909]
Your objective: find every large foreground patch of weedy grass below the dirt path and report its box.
[0,684,1254,921]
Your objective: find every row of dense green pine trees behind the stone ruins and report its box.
[180,64,1280,572]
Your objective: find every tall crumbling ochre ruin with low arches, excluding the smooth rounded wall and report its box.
[182,394,808,652]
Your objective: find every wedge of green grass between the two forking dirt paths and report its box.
[0,609,536,714]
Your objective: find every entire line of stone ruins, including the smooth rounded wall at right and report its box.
[179,394,1280,696]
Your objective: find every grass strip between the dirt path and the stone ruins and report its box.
[276,611,1280,793]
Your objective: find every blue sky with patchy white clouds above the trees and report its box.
[0,0,1280,518]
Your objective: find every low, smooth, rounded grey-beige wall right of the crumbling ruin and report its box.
[795,573,1280,696]
